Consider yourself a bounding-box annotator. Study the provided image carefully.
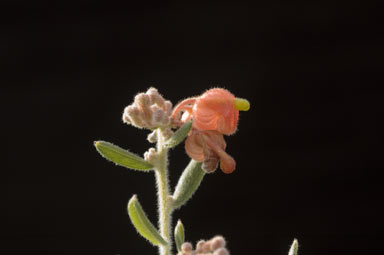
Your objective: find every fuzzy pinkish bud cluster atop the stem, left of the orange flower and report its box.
[123,88,172,130]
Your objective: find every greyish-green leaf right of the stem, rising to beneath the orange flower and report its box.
[173,159,205,209]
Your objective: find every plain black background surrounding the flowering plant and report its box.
[0,1,384,255]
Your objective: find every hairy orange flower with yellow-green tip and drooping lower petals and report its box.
[172,88,249,174]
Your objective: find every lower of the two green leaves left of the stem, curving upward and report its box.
[128,195,167,246]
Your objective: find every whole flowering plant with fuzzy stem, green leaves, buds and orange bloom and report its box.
[95,88,297,255]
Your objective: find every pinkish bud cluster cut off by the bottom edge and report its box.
[178,236,229,255]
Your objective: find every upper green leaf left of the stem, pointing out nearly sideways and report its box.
[95,141,153,171]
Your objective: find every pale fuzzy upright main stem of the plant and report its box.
[155,128,172,255]
